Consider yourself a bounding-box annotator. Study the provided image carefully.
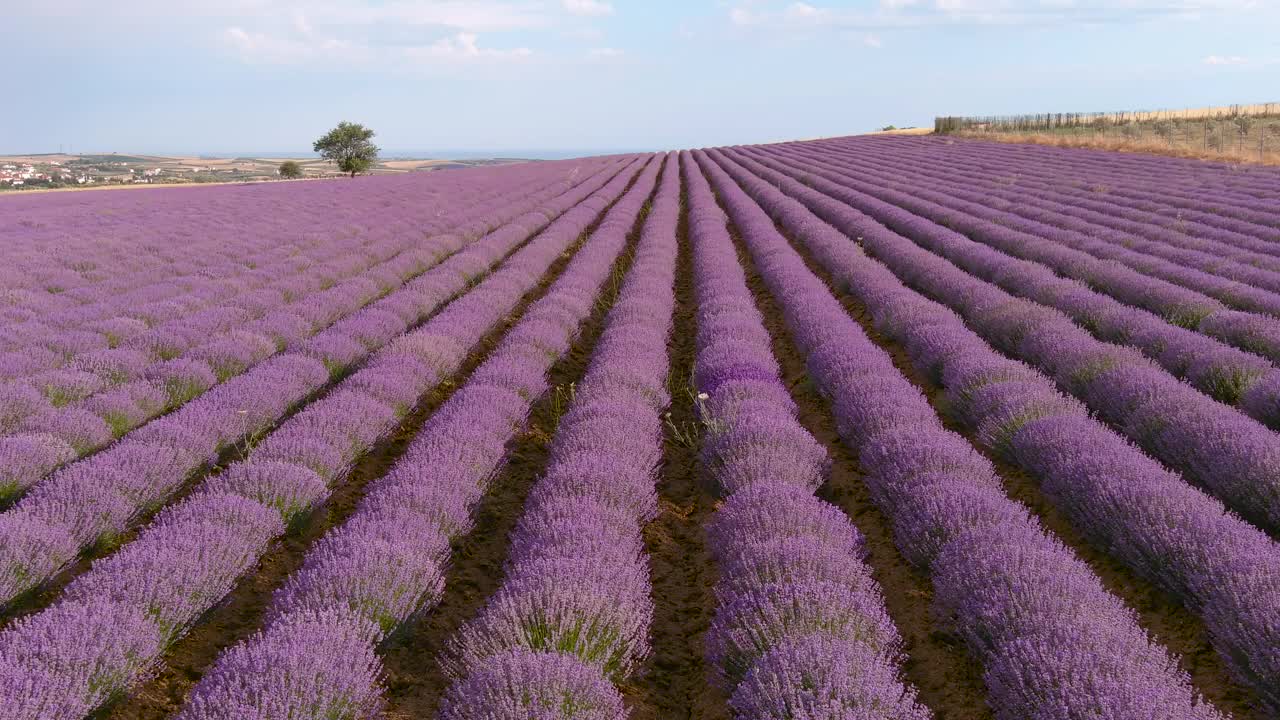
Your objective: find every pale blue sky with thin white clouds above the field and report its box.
[0,0,1280,155]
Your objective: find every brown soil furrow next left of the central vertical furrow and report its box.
[380,156,648,720]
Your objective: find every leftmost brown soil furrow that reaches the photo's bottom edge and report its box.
[97,163,640,720]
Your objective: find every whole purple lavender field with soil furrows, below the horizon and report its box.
[0,136,1280,720]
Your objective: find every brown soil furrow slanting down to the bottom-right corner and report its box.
[757,185,1267,720]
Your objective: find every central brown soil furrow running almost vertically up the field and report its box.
[622,175,728,720]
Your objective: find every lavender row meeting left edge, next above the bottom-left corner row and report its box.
[0,156,627,609]
